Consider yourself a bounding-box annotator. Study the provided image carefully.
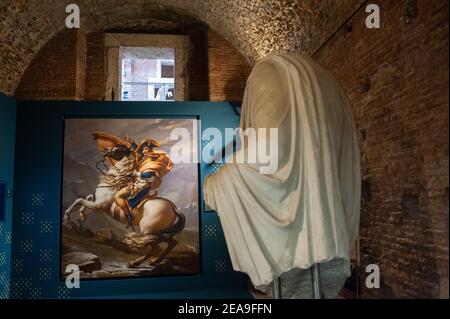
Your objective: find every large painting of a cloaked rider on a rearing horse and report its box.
[60,117,200,279]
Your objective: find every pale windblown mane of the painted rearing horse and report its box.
[100,154,136,190]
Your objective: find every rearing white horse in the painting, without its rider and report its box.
[63,149,185,267]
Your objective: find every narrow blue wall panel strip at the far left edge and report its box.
[0,93,16,299]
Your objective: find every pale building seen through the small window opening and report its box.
[120,47,175,101]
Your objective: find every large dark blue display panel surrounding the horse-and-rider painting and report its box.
[11,102,250,298]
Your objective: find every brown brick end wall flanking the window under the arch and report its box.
[15,27,251,101]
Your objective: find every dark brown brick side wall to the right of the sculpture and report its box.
[314,0,449,298]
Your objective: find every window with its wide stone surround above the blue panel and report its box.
[105,33,189,101]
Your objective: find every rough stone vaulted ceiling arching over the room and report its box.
[0,0,364,95]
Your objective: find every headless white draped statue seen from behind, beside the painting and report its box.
[204,54,360,298]
